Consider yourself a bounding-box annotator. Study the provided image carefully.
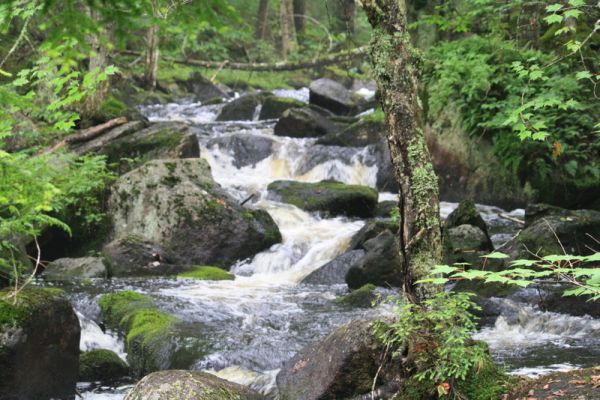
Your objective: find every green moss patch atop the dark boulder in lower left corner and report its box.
[0,289,64,326]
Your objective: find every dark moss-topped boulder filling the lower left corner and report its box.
[0,289,80,400]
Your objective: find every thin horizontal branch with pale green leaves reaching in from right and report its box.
[421,252,600,300]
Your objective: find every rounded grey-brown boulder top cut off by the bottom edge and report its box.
[125,370,265,400]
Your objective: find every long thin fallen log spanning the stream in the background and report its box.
[121,46,367,72]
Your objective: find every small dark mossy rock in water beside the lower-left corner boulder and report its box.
[79,349,129,383]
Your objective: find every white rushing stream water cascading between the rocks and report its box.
[64,90,600,400]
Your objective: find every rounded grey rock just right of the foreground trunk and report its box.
[444,224,494,268]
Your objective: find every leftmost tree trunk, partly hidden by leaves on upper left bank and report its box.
[79,7,109,120]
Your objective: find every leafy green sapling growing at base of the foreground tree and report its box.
[375,293,487,394]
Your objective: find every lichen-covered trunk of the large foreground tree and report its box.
[360,0,442,302]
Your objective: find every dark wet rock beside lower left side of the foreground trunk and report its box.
[346,230,403,289]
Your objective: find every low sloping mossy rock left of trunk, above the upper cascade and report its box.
[317,119,386,147]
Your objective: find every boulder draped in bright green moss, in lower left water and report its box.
[100,291,208,377]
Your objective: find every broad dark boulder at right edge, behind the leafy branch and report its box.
[503,209,600,259]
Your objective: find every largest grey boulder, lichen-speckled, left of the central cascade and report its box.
[109,159,281,265]
